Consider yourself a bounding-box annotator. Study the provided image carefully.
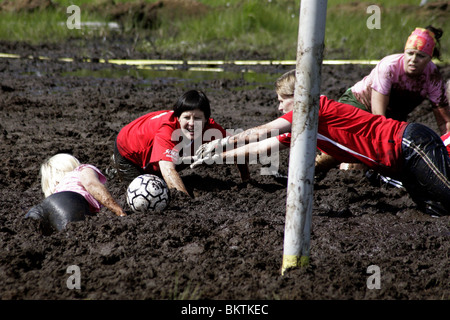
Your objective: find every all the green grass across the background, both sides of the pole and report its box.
[0,0,450,62]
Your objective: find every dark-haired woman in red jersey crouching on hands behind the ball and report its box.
[114,90,249,196]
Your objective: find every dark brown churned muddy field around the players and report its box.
[0,36,450,312]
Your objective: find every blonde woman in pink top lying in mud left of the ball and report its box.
[25,153,126,231]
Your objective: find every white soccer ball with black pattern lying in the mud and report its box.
[127,174,170,213]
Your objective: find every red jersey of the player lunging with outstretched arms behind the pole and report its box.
[278,96,408,174]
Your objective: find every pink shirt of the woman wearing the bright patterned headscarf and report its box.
[352,53,448,120]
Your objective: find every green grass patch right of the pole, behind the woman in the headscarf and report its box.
[325,1,450,61]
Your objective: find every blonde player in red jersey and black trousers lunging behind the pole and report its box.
[192,70,450,216]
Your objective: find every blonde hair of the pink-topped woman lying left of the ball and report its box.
[40,153,80,198]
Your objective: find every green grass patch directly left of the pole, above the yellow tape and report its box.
[140,1,298,59]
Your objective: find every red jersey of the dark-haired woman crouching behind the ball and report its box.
[116,110,226,172]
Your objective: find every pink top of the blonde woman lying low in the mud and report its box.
[54,164,106,212]
